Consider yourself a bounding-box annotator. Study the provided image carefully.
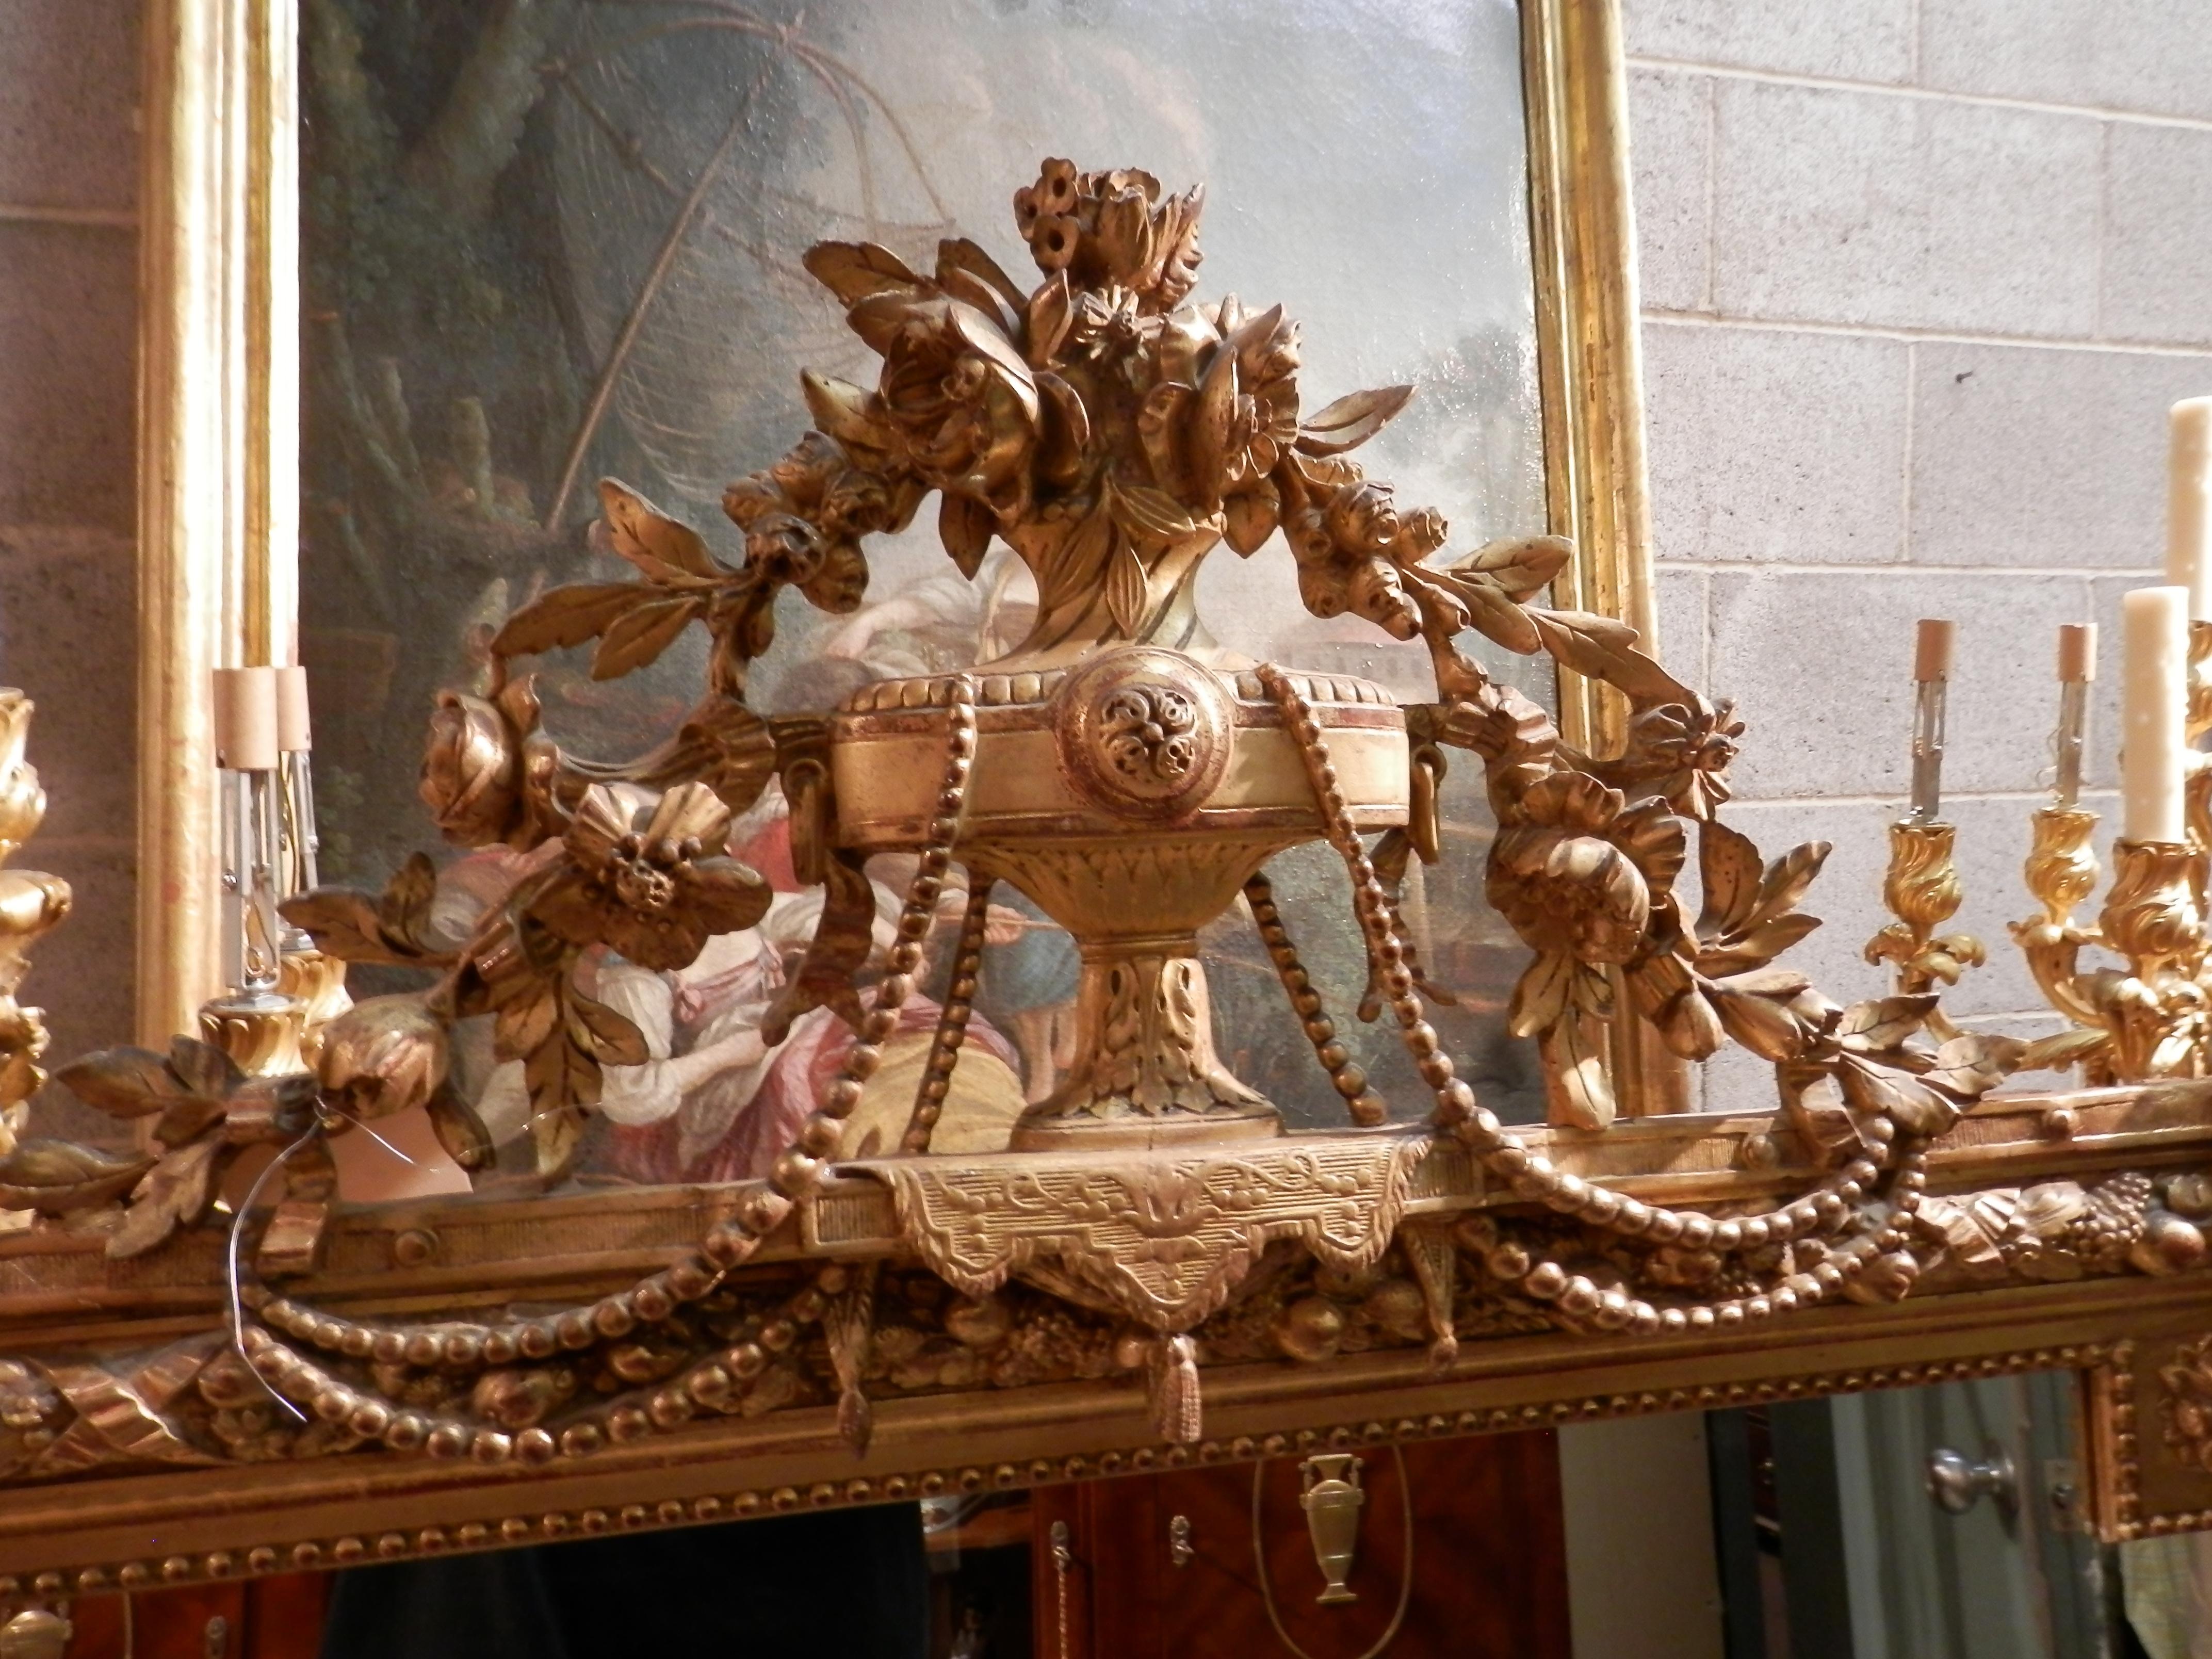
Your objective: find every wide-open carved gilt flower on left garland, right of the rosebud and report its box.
[533,783,770,971]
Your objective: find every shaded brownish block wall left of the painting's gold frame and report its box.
[0,0,139,1084]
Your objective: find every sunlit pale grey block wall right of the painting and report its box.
[1623,0,2212,1108]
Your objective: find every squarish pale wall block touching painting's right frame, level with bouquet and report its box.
[1644,321,1907,564]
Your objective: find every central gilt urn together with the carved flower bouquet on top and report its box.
[787,161,1442,1150]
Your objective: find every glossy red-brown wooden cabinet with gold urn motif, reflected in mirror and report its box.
[1031,1431,1573,1659]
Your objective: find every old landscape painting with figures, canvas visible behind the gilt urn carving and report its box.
[258,0,1641,1181]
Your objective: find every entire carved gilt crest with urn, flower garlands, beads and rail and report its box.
[0,159,2212,1590]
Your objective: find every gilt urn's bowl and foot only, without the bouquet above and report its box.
[832,642,1409,1150]
